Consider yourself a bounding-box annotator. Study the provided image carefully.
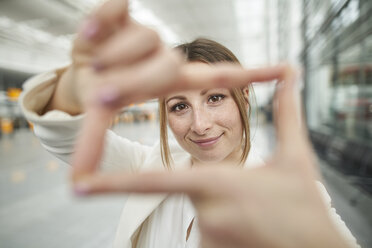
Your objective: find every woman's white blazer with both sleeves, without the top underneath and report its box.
[20,71,359,248]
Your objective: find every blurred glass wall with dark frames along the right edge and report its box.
[303,0,372,145]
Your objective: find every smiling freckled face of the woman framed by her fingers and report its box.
[165,88,243,163]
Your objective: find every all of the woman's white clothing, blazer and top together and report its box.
[20,68,359,248]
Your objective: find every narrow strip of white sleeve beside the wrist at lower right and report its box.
[316,181,360,248]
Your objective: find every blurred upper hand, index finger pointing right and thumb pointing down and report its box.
[64,0,288,180]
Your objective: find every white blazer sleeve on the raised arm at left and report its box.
[20,68,152,171]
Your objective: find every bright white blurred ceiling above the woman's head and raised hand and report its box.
[0,0,277,72]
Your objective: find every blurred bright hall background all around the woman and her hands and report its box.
[0,0,372,248]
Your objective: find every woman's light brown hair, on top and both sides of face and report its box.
[159,39,253,169]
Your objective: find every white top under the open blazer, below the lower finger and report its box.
[137,194,200,248]
